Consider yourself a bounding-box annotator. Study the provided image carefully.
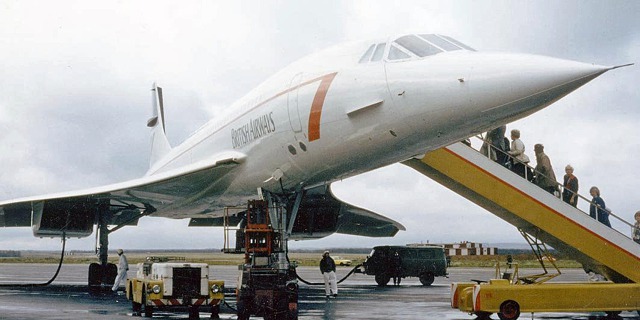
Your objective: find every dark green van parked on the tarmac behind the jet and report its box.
[360,245,447,286]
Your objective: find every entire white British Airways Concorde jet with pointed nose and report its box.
[0,34,615,284]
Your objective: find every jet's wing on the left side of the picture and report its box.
[0,151,246,237]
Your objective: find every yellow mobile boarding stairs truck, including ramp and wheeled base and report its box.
[403,143,640,319]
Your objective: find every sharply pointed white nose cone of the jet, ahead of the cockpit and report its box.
[467,54,611,121]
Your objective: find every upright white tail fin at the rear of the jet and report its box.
[147,82,171,167]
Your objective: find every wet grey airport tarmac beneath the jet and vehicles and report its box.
[0,264,640,320]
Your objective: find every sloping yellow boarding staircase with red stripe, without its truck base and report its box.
[403,143,640,283]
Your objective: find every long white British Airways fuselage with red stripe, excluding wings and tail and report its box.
[148,36,607,213]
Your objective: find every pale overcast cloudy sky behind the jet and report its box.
[0,0,640,250]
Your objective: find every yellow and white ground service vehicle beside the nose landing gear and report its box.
[126,258,224,319]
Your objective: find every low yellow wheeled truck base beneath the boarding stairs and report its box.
[451,260,640,320]
